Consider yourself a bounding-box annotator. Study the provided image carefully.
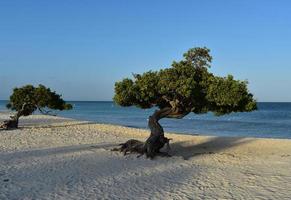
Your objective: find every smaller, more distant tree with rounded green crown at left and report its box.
[2,85,72,129]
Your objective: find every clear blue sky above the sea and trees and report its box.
[0,0,291,102]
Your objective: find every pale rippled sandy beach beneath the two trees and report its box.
[0,114,291,200]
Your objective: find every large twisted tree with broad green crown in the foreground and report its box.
[114,47,257,157]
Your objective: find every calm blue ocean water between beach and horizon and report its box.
[0,101,291,139]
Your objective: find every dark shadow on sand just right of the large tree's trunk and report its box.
[171,137,252,160]
